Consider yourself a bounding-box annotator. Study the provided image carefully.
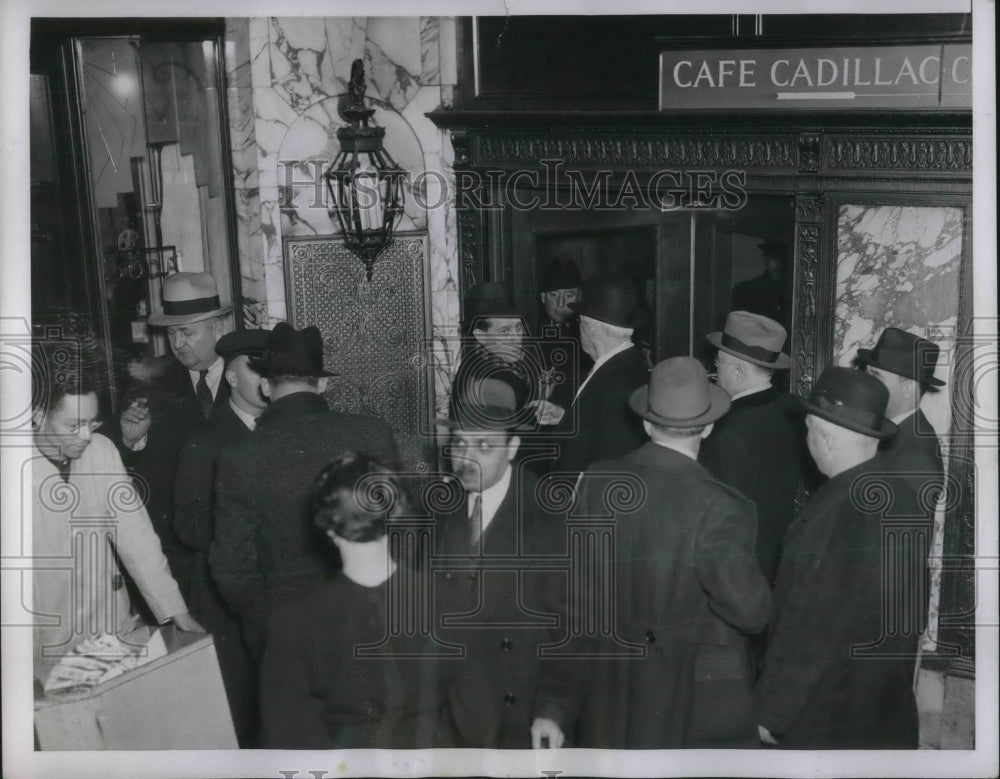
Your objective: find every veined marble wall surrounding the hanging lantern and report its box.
[227,17,458,410]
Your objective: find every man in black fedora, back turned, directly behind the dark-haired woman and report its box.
[209,322,399,660]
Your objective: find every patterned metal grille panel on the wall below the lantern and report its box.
[285,232,434,471]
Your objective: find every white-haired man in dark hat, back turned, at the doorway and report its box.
[554,270,649,473]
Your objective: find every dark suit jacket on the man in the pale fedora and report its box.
[108,357,229,597]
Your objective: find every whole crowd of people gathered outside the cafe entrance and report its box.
[32,259,943,749]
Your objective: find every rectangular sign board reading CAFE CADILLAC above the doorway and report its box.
[660,44,972,111]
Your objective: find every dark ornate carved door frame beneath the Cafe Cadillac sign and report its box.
[440,112,975,671]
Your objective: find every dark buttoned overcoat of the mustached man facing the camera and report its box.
[435,465,566,749]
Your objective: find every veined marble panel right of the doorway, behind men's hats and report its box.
[833,205,965,649]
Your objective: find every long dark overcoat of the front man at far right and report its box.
[756,455,926,749]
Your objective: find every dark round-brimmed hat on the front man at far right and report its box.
[798,365,899,438]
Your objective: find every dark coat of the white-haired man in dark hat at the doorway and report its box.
[555,346,649,473]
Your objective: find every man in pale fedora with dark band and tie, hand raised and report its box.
[110,272,233,596]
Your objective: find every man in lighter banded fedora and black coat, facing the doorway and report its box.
[699,311,806,584]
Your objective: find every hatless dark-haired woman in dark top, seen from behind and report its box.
[261,452,450,749]
